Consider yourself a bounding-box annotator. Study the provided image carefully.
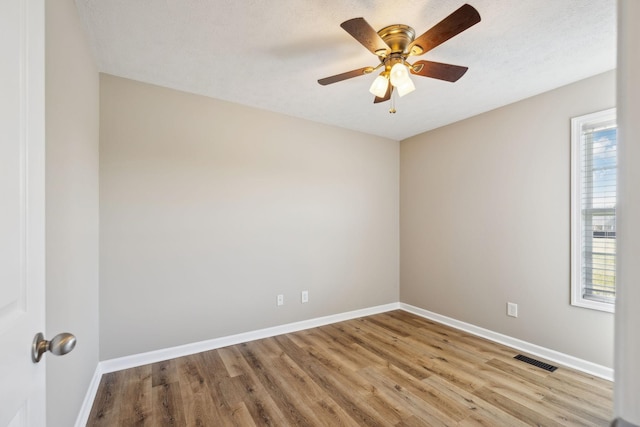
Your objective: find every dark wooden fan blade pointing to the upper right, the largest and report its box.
[409,4,480,55]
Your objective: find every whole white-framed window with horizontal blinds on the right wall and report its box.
[571,108,618,312]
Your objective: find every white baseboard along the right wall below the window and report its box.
[400,303,613,381]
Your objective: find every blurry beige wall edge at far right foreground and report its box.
[614,0,640,426]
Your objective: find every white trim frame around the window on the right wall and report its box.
[571,107,618,313]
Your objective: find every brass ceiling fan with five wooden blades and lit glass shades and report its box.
[318,4,480,113]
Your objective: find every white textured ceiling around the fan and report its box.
[76,0,616,140]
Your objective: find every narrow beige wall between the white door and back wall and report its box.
[46,0,99,427]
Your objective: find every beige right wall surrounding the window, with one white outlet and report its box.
[400,72,615,367]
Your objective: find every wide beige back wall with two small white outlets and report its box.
[100,75,399,359]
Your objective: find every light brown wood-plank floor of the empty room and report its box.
[88,311,612,427]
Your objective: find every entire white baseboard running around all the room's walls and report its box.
[75,302,613,427]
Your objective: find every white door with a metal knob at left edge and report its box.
[0,0,45,427]
